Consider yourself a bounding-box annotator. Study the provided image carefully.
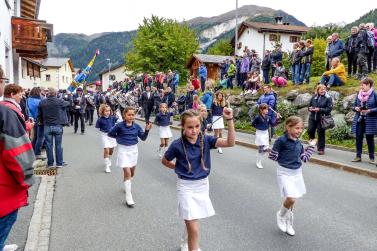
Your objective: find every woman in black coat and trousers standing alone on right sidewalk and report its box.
[308,85,333,155]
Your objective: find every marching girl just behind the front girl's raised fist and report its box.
[211,91,225,153]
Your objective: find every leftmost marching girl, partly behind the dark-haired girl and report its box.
[96,104,118,173]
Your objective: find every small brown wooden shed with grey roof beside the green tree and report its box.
[186,54,234,80]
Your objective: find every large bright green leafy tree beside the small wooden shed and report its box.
[125,15,199,80]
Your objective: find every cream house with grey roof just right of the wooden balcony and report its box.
[39,58,74,90]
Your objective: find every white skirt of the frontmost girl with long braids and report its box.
[177,178,215,220]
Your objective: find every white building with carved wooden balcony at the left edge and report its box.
[0,0,53,85]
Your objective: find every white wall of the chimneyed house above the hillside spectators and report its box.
[237,28,297,57]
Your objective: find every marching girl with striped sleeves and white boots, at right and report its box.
[268,116,317,236]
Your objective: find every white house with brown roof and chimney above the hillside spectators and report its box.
[232,17,309,57]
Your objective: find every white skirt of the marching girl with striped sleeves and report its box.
[277,166,306,198]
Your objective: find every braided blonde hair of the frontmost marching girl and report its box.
[181,109,208,173]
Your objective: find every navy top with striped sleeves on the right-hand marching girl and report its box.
[268,133,314,169]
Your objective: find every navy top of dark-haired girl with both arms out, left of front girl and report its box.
[107,121,149,146]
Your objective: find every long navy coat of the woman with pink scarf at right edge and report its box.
[352,92,377,135]
